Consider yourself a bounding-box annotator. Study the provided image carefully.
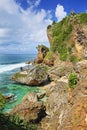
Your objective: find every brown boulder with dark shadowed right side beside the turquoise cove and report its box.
[10,93,45,123]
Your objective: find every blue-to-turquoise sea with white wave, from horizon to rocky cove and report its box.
[0,54,38,112]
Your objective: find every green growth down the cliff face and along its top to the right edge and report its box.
[48,13,87,62]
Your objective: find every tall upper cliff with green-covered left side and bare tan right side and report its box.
[47,13,87,61]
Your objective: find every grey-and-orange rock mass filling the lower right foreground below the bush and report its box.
[39,75,87,130]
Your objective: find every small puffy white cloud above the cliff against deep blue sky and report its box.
[55,4,67,21]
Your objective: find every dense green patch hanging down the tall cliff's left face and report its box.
[50,17,72,61]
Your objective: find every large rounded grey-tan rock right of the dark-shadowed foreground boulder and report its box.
[46,82,68,116]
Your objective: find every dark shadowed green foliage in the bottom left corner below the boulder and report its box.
[0,113,37,130]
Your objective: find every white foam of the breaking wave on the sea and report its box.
[0,63,26,73]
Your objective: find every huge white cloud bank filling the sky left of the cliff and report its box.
[0,0,52,52]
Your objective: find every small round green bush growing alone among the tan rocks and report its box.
[68,73,78,88]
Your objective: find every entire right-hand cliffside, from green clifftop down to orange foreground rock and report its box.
[40,13,87,130]
